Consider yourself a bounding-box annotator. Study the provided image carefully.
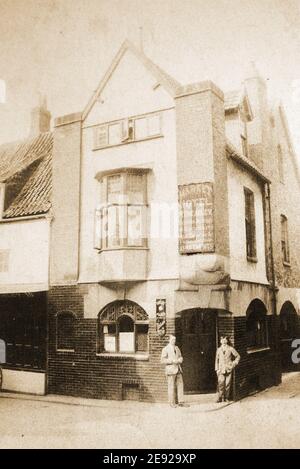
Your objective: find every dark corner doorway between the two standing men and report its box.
[181,309,217,394]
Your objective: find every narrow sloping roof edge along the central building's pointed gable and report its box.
[82,40,181,120]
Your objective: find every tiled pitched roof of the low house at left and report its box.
[0,132,53,219]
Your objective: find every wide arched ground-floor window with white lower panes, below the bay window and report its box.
[98,301,149,354]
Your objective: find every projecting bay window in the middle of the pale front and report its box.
[95,170,147,249]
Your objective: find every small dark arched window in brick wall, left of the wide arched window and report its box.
[56,311,76,351]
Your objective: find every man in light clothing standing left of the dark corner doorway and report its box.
[161,335,186,407]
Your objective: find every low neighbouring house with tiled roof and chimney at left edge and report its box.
[0,103,52,394]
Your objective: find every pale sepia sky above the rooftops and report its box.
[0,0,300,154]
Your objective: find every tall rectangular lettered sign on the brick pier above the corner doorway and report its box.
[179,182,215,254]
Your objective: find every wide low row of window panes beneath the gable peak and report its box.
[94,114,161,149]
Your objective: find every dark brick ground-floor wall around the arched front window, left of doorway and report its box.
[48,286,175,402]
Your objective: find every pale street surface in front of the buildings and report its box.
[0,373,300,449]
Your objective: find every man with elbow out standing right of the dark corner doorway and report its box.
[215,337,241,402]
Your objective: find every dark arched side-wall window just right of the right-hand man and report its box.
[246,300,269,350]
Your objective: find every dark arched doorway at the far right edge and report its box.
[279,301,299,372]
